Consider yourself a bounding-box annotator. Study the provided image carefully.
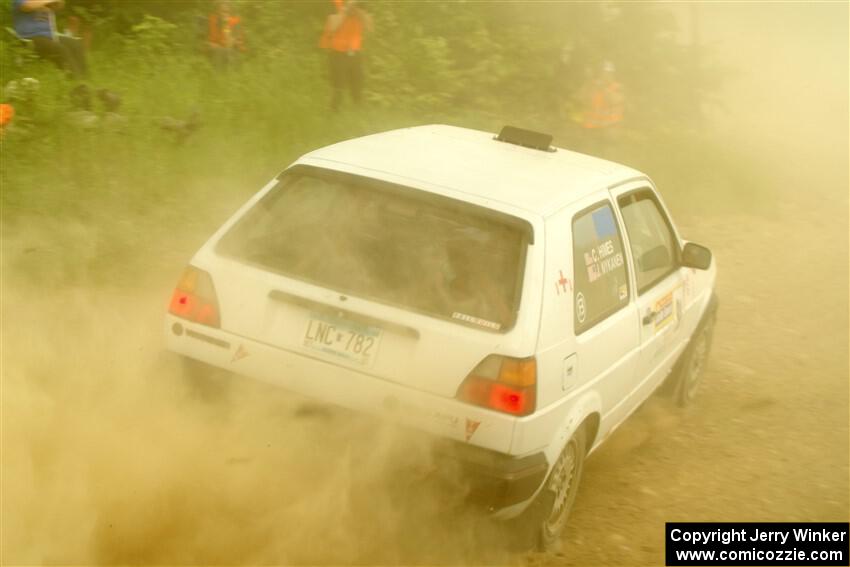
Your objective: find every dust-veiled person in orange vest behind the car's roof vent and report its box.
[581,61,625,157]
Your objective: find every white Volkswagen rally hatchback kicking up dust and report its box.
[165,126,717,545]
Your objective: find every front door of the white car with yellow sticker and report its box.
[612,182,683,400]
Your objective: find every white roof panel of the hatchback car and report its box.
[302,125,646,217]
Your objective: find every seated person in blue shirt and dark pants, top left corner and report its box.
[12,0,88,79]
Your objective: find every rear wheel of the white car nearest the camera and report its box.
[536,427,587,551]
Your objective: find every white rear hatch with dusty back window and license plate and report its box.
[210,165,532,397]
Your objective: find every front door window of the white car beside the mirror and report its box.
[618,193,679,294]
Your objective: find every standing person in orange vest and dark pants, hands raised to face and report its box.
[319,0,372,110]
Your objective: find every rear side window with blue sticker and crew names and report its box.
[573,201,629,334]
